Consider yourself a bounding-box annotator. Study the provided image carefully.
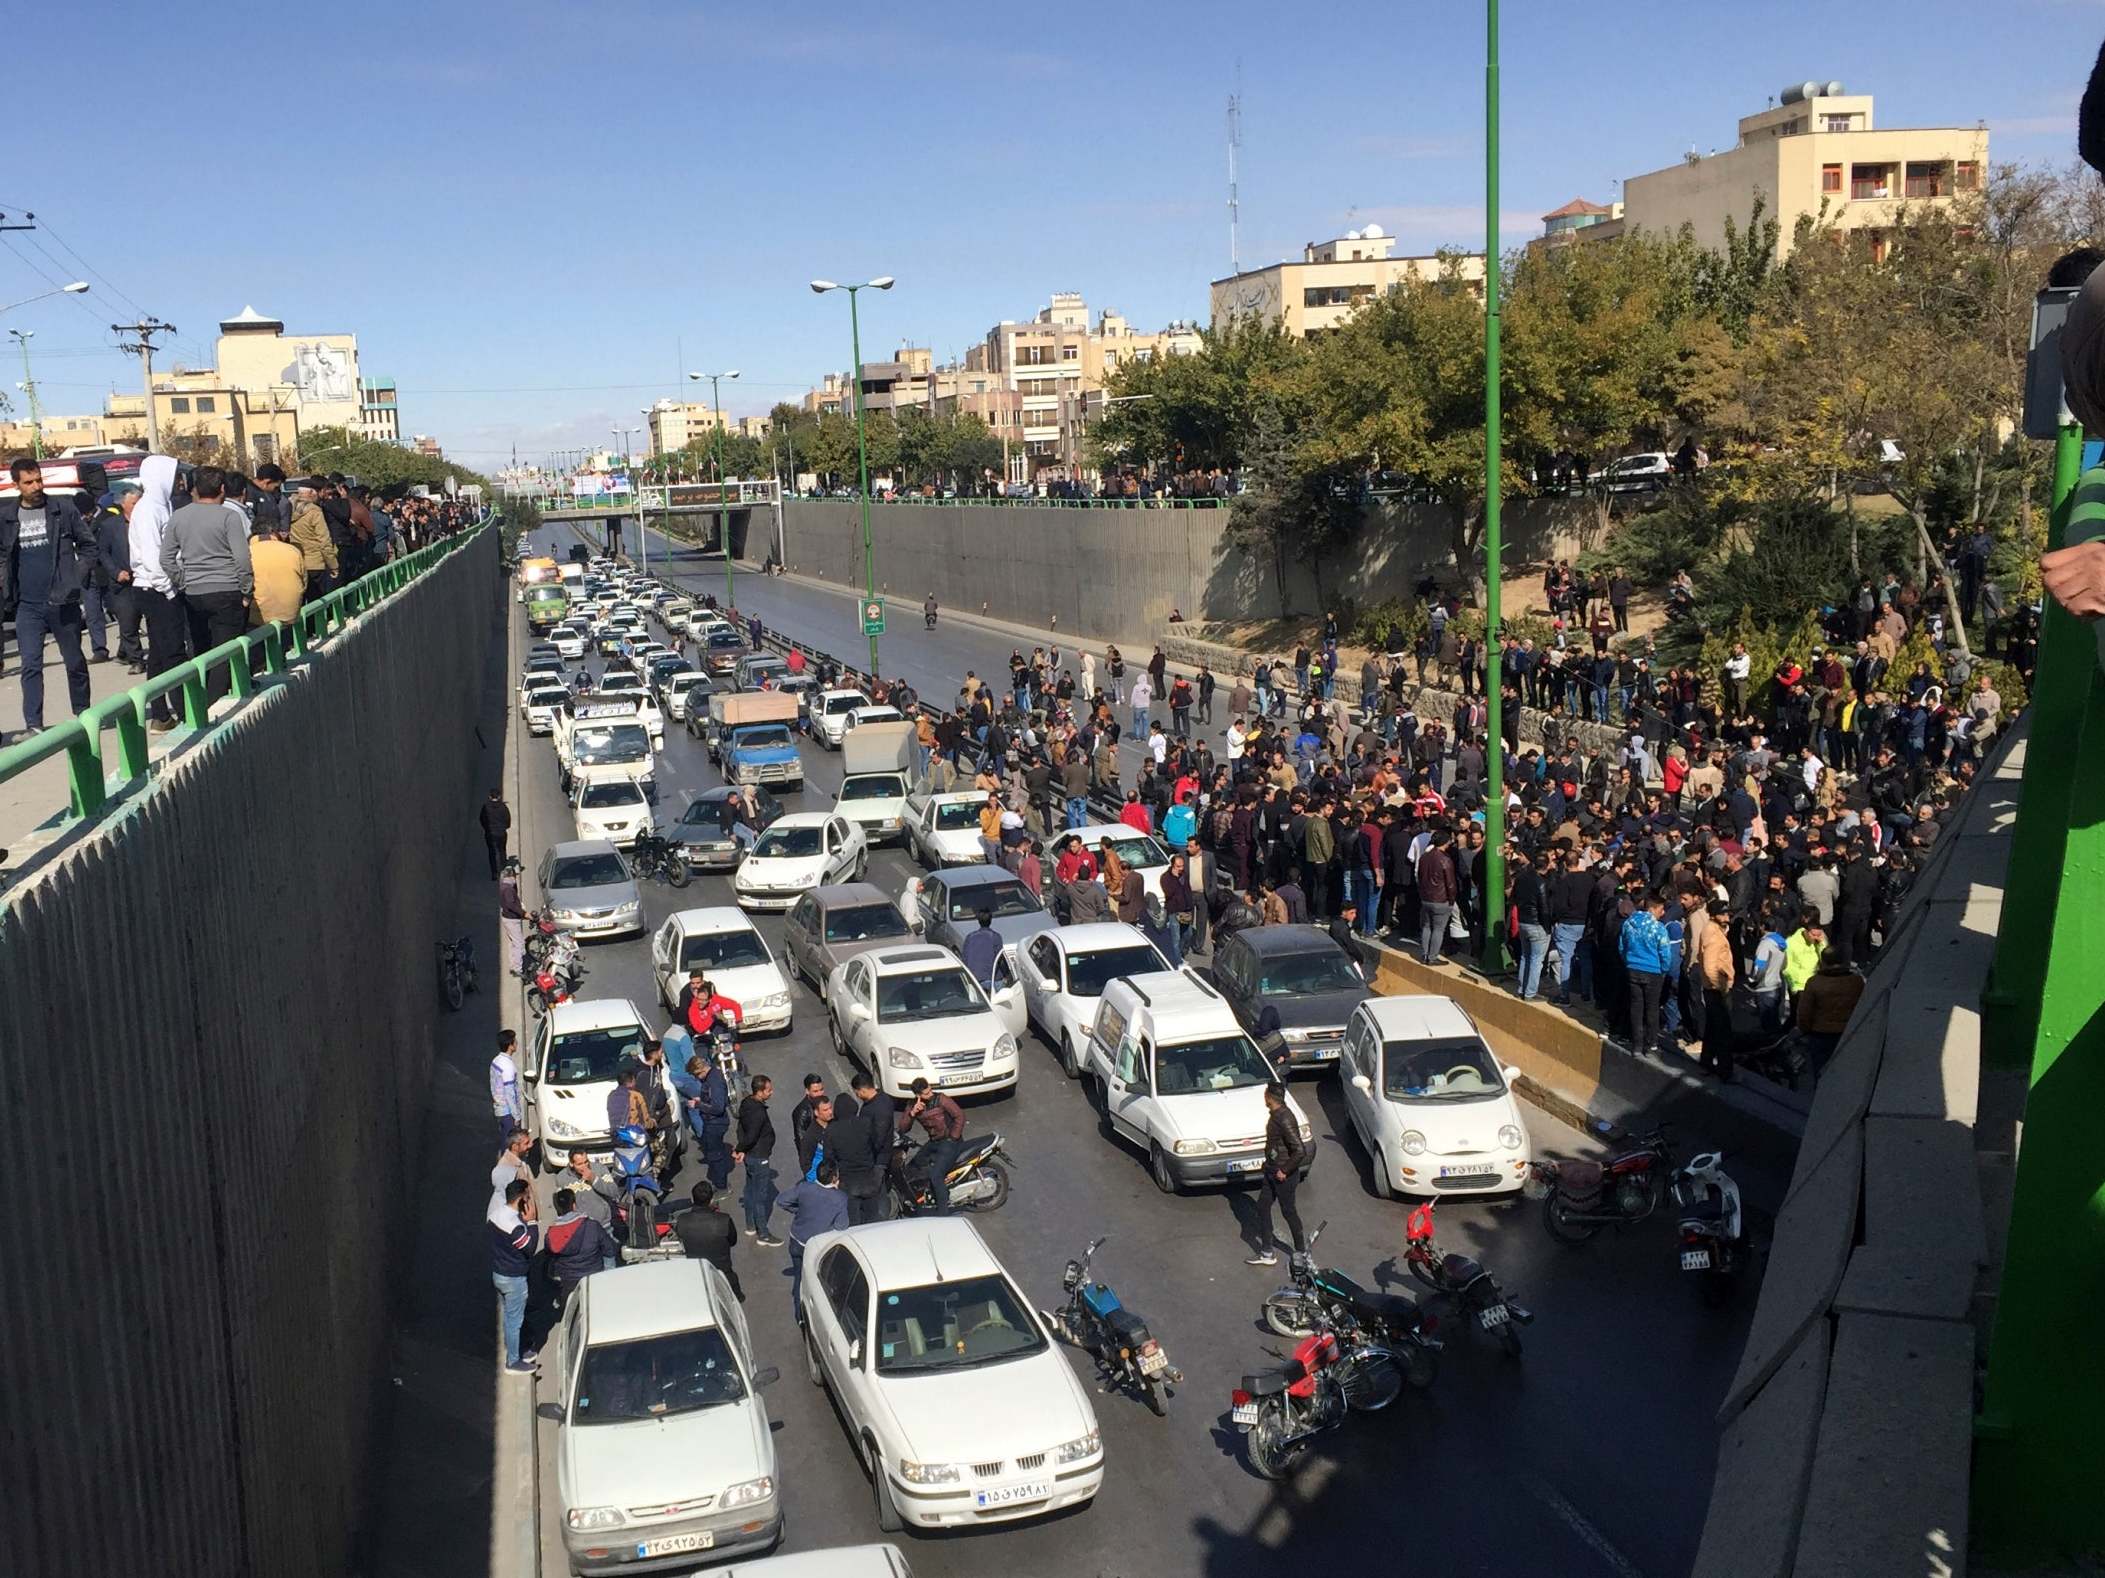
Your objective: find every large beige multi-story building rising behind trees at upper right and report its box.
[1616,82,1987,257]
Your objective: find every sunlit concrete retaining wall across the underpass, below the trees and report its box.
[783,499,1606,642]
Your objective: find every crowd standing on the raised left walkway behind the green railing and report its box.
[0,454,474,736]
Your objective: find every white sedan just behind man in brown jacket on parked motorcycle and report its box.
[825,943,1023,1096]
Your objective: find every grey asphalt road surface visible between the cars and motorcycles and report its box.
[512,528,1789,1578]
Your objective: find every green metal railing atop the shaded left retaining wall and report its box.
[0,526,488,816]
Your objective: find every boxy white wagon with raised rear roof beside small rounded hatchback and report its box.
[1084,970,1311,1195]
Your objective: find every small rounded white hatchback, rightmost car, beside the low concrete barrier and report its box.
[1339,997,1532,1197]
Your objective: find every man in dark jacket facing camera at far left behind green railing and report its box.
[0,459,95,743]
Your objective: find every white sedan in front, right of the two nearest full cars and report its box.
[798,1216,1103,1532]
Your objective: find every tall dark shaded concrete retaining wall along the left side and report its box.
[0,532,503,1578]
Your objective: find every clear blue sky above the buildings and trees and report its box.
[0,0,2105,467]
